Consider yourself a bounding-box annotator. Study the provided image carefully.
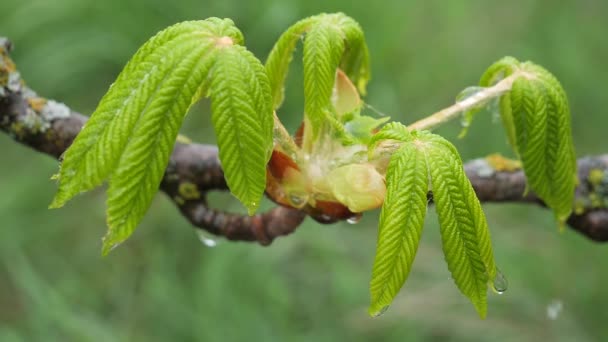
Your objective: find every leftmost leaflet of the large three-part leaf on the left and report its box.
[51,19,240,208]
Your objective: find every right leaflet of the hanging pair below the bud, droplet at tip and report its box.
[418,132,496,318]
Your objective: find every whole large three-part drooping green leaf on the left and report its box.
[51,18,273,254]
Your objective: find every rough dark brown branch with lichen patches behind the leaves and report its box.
[0,38,608,245]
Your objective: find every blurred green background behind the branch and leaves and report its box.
[0,0,608,341]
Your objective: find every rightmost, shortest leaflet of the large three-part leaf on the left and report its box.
[209,46,273,215]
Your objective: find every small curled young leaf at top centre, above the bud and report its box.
[266,13,370,144]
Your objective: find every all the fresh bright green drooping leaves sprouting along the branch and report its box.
[51,13,576,317]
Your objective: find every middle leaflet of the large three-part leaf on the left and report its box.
[102,42,218,254]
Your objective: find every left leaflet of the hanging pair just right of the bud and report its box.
[369,143,429,316]
